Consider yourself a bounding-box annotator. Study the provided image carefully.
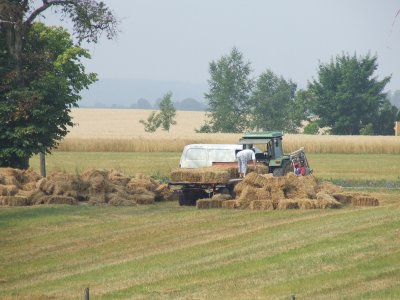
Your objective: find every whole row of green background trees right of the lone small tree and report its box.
[198,47,400,135]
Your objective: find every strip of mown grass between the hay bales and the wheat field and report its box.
[30,152,400,181]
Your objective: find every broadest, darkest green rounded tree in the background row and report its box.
[308,54,390,135]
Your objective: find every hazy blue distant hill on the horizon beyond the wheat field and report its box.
[79,79,207,110]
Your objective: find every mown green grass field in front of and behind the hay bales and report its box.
[0,152,400,299]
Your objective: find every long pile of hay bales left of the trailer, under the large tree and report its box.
[0,168,172,206]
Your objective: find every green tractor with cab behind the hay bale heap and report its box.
[239,131,312,176]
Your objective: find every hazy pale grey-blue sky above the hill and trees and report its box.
[42,0,400,90]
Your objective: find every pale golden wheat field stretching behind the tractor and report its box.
[58,108,400,154]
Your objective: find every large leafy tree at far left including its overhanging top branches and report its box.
[0,0,118,168]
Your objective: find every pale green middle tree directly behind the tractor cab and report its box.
[251,70,304,133]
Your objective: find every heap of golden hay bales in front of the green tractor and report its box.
[197,173,379,210]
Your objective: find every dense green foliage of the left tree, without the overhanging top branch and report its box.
[0,23,96,168]
